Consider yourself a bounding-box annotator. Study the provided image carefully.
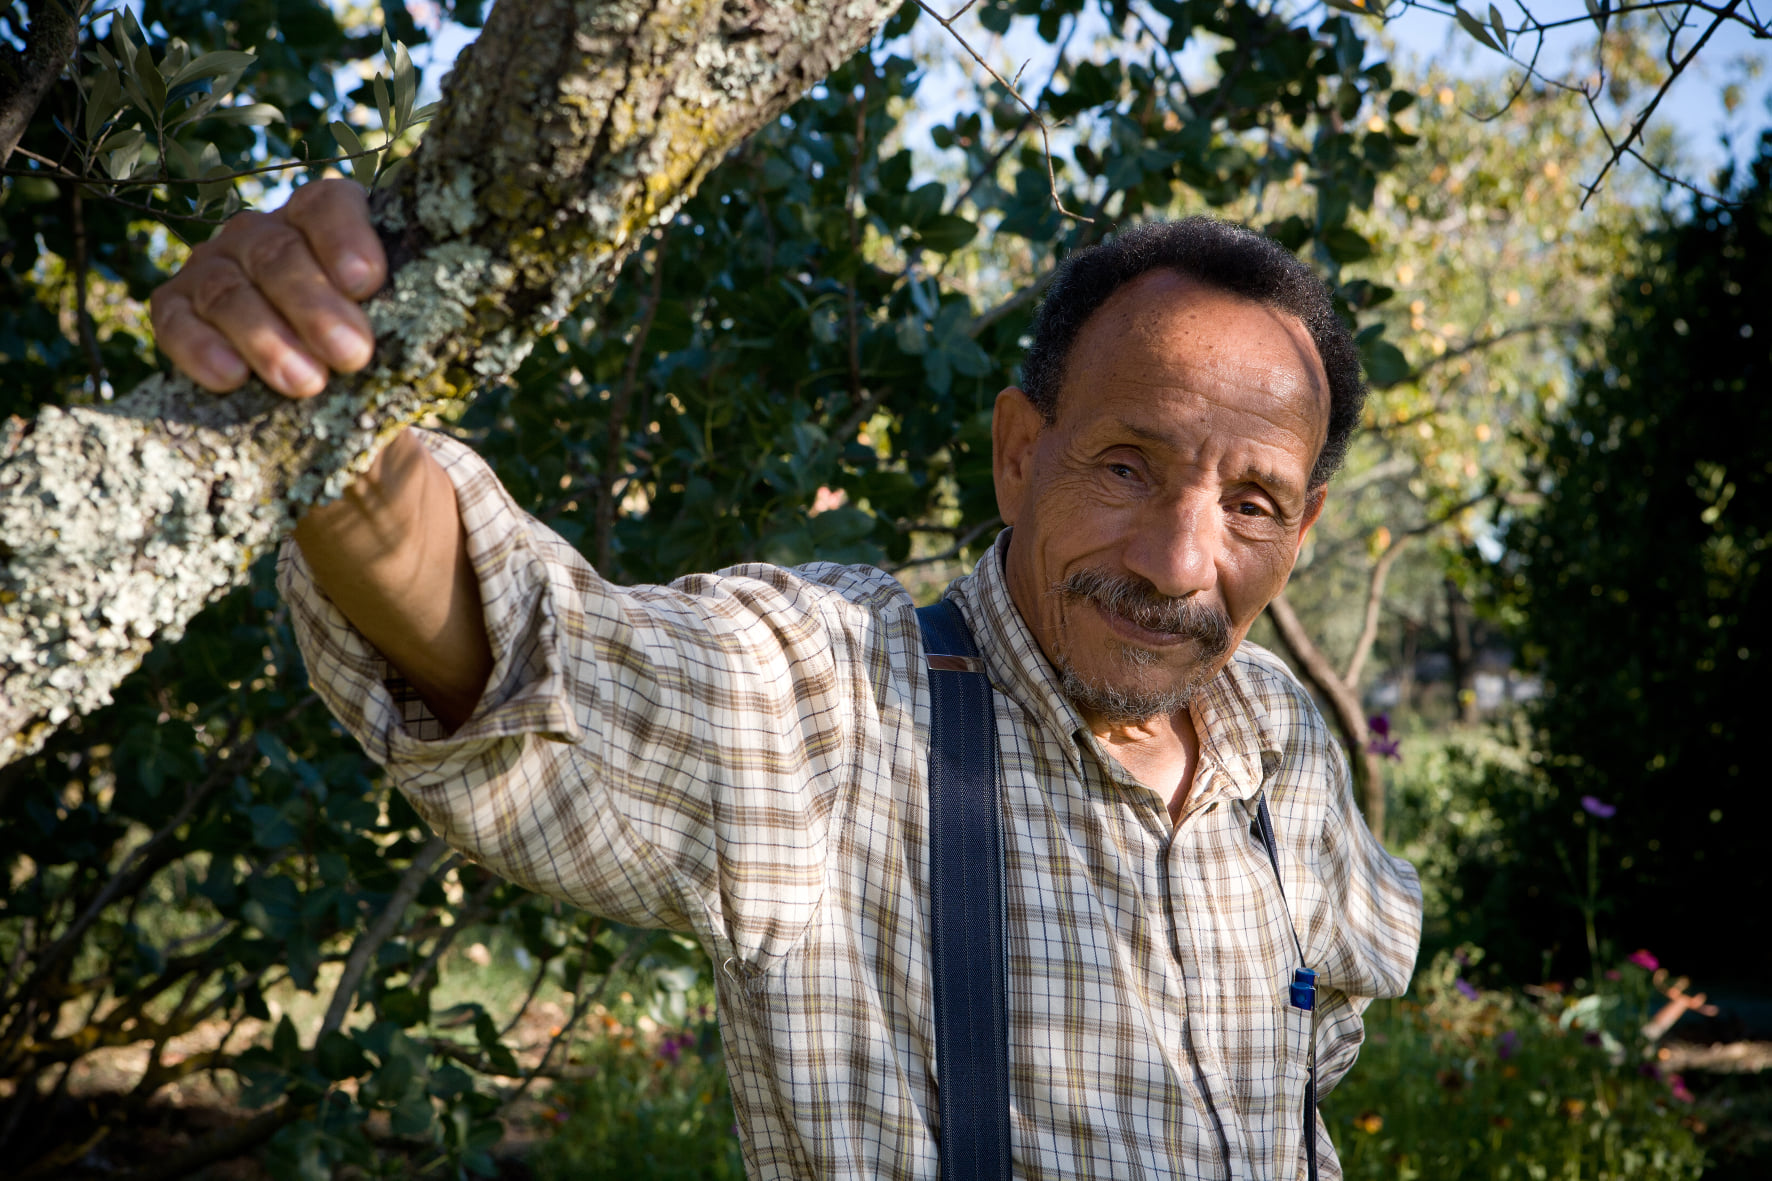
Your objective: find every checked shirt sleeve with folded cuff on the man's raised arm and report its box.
[278,434,884,958]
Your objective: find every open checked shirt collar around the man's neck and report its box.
[948,528,1279,812]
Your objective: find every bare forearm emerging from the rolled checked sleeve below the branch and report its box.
[296,431,493,729]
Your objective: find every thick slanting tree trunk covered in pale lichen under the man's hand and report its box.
[0,0,897,764]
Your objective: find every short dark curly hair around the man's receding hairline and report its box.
[1021,216,1366,488]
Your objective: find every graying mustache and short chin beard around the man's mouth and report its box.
[1053,569,1232,722]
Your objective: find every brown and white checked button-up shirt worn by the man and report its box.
[280,434,1421,1181]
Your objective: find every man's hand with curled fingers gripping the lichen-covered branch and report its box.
[152,181,388,397]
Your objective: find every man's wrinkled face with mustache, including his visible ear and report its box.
[992,271,1329,722]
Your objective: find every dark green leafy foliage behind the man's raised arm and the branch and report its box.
[0,0,1414,1177]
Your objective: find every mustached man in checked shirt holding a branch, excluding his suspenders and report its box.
[154,183,1419,1181]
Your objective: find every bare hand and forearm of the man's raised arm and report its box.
[152,181,493,729]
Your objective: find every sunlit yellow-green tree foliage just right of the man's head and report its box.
[1262,46,1671,828]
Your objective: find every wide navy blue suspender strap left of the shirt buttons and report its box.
[916,599,1010,1181]
